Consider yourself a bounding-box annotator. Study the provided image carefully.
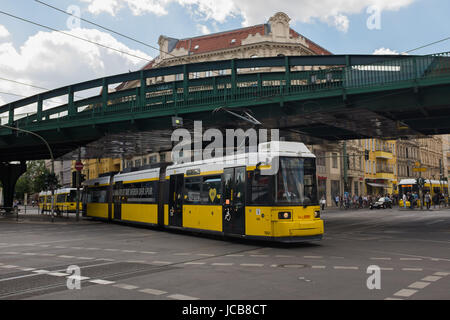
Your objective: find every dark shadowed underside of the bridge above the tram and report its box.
[0,85,450,161]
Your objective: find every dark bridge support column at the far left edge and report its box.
[0,161,27,208]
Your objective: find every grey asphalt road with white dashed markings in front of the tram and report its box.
[0,209,450,300]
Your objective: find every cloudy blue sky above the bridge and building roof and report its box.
[0,0,450,117]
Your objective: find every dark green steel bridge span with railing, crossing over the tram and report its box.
[0,54,450,160]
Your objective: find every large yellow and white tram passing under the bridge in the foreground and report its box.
[83,142,324,242]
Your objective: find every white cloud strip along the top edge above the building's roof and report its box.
[82,0,415,32]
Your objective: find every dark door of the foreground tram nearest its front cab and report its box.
[222,167,246,235]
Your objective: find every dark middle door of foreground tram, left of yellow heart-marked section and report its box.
[169,174,184,227]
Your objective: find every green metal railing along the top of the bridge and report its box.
[0,53,450,131]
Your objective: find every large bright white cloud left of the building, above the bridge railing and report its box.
[0,29,152,114]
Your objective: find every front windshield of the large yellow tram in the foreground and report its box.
[275,157,318,205]
